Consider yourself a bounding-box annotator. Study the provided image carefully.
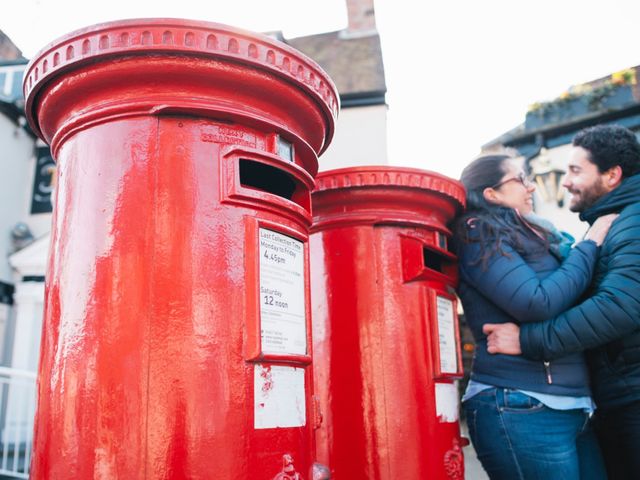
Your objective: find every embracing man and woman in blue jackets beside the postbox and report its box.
[454,126,640,480]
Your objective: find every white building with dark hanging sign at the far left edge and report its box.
[0,55,53,478]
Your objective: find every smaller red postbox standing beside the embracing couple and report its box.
[310,166,464,480]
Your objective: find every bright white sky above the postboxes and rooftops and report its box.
[0,0,640,177]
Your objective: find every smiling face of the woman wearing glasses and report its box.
[484,159,536,215]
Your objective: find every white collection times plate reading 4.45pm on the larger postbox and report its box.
[259,228,307,355]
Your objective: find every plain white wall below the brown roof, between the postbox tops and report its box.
[319,105,389,171]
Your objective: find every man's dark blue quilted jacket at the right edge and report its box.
[520,175,640,408]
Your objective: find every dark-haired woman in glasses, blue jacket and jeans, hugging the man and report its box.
[454,155,615,480]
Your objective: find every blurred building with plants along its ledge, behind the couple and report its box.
[482,66,640,238]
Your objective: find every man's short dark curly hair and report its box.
[573,125,640,178]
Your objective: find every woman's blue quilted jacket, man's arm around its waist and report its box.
[456,209,598,396]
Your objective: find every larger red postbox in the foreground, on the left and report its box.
[24,19,339,480]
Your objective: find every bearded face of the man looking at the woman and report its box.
[562,147,610,212]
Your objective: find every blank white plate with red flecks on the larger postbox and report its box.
[253,363,306,429]
